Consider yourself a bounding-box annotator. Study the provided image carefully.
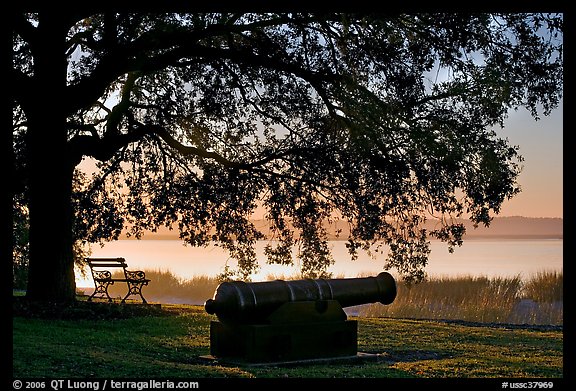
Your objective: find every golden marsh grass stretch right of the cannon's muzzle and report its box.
[358,272,563,325]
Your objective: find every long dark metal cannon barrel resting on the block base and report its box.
[204,272,396,324]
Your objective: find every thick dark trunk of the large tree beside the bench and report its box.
[23,11,76,301]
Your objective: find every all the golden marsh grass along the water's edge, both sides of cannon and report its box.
[88,270,563,325]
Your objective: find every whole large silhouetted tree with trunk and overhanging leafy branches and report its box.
[10,10,563,300]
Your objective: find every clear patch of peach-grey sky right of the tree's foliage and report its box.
[498,101,564,217]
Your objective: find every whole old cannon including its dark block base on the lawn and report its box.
[204,272,396,363]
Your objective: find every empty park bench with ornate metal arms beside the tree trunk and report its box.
[86,258,150,304]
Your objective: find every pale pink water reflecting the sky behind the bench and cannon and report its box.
[76,239,563,287]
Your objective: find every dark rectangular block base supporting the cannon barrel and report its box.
[210,320,358,363]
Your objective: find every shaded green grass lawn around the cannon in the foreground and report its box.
[12,299,564,388]
